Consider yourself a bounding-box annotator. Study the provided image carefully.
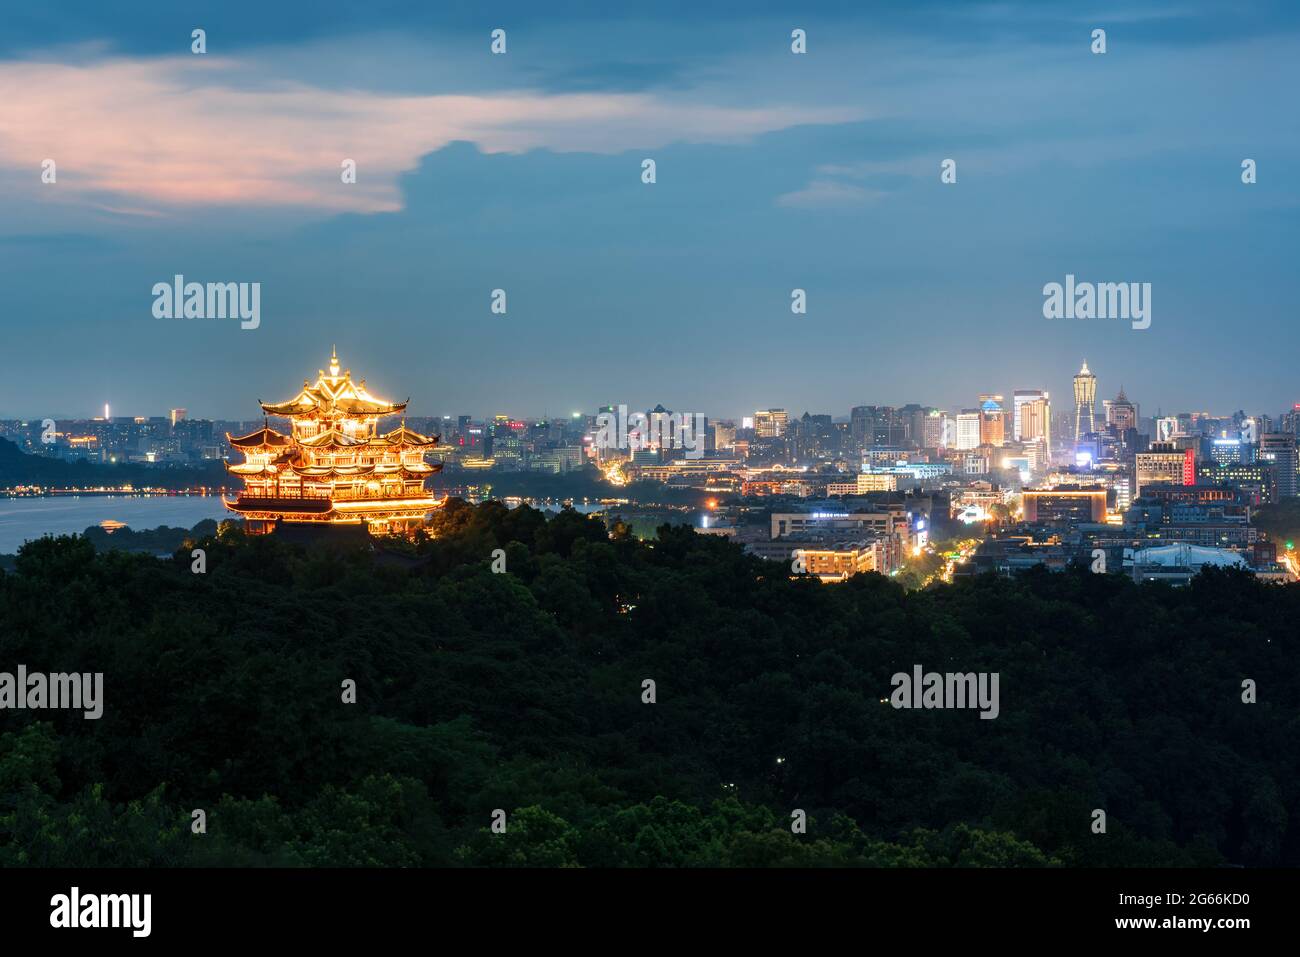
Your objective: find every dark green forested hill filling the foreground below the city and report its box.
[0,501,1300,866]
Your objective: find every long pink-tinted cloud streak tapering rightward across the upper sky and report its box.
[0,56,861,213]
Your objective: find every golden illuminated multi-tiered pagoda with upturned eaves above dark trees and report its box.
[225,351,442,533]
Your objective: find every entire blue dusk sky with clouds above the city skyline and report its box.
[0,0,1300,419]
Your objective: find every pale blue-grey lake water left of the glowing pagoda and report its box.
[0,495,234,555]
